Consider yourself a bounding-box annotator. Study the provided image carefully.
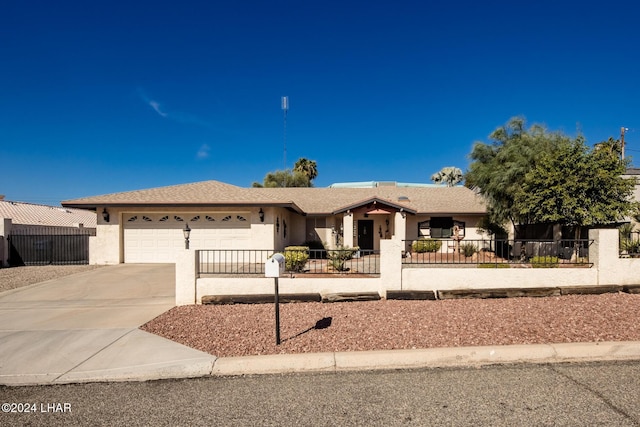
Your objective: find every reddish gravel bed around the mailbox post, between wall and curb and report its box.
[141,292,640,357]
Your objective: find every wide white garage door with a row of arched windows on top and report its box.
[123,212,251,263]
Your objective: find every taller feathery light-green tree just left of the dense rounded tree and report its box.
[464,117,567,226]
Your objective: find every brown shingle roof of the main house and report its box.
[62,181,486,215]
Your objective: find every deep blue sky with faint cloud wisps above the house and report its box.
[0,0,640,204]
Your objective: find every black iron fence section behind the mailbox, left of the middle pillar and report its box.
[197,249,380,276]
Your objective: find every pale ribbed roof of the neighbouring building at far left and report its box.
[0,200,96,228]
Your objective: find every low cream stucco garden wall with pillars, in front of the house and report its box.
[176,229,640,305]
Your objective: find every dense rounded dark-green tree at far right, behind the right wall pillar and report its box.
[514,136,635,239]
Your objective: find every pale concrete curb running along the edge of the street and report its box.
[5,341,640,387]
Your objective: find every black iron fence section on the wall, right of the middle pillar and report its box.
[402,239,593,267]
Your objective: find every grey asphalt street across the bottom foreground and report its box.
[0,361,640,426]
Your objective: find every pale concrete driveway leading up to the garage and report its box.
[0,264,215,385]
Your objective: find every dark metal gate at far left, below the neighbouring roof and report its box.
[7,227,95,267]
